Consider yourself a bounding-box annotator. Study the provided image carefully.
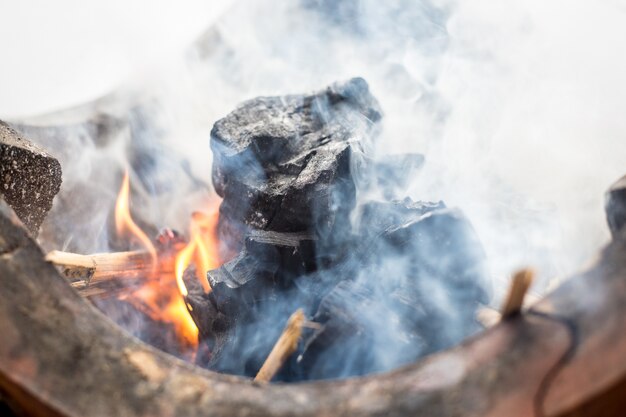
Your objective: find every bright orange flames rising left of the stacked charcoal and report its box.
[115,174,219,358]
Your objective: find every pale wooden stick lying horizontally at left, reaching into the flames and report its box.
[46,251,174,285]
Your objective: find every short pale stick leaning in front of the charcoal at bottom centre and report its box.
[254,309,305,382]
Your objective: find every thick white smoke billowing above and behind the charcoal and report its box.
[8,0,626,340]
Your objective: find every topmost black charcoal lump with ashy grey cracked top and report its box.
[211,78,381,249]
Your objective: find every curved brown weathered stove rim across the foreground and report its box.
[0,196,626,417]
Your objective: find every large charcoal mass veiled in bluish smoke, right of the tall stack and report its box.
[302,200,489,379]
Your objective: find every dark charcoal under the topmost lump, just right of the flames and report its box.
[188,231,316,376]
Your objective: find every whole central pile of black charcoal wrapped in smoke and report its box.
[188,78,489,381]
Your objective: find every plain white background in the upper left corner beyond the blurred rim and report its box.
[0,0,230,119]
